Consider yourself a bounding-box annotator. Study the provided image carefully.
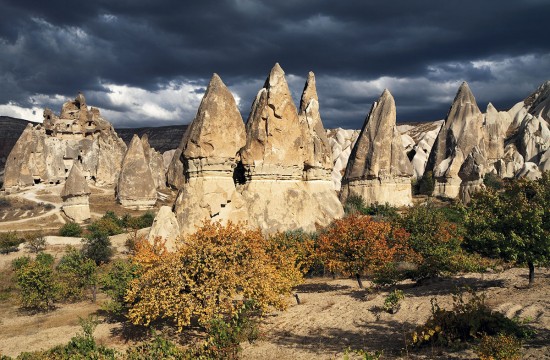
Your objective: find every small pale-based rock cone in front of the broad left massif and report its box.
[61,163,91,223]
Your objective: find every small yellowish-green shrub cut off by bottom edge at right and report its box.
[476,334,521,360]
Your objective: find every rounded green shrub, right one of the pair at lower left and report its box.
[57,247,97,302]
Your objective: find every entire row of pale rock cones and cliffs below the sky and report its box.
[4,64,550,243]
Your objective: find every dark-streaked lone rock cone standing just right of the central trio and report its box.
[340,90,413,206]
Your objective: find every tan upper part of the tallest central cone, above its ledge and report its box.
[241,64,305,180]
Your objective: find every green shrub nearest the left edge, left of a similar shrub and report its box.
[12,253,59,310]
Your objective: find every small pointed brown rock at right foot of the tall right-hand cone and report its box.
[458,146,487,204]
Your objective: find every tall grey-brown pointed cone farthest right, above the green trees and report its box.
[426,82,484,198]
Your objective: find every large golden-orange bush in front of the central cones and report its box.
[126,223,302,331]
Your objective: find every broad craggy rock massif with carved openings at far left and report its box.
[4,94,126,189]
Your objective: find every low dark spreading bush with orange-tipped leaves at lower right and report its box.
[411,290,532,346]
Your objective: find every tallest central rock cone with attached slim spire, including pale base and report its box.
[241,64,343,232]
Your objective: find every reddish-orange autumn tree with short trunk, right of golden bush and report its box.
[318,214,414,288]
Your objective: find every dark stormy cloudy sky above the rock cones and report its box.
[0,0,550,128]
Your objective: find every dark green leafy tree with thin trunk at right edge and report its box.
[465,172,550,286]
